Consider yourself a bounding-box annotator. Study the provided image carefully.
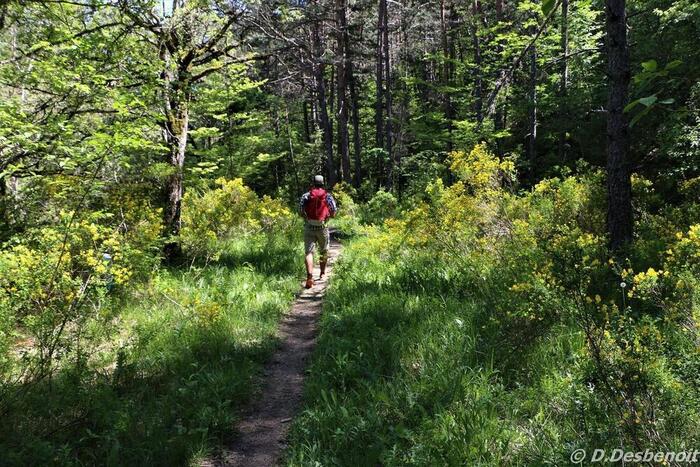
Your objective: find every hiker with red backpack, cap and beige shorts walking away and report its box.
[299,175,338,289]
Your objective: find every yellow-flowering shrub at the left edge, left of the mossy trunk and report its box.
[0,212,159,377]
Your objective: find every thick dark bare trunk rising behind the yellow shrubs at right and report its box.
[605,0,633,251]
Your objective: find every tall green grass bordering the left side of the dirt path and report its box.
[0,236,301,465]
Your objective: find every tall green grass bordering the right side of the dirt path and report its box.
[286,239,600,466]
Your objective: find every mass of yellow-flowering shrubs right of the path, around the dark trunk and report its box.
[360,145,700,458]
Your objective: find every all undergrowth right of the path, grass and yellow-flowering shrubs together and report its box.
[287,146,700,465]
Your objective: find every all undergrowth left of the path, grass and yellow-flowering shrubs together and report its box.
[0,163,302,465]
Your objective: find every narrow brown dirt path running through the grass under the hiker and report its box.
[201,241,341,467]
